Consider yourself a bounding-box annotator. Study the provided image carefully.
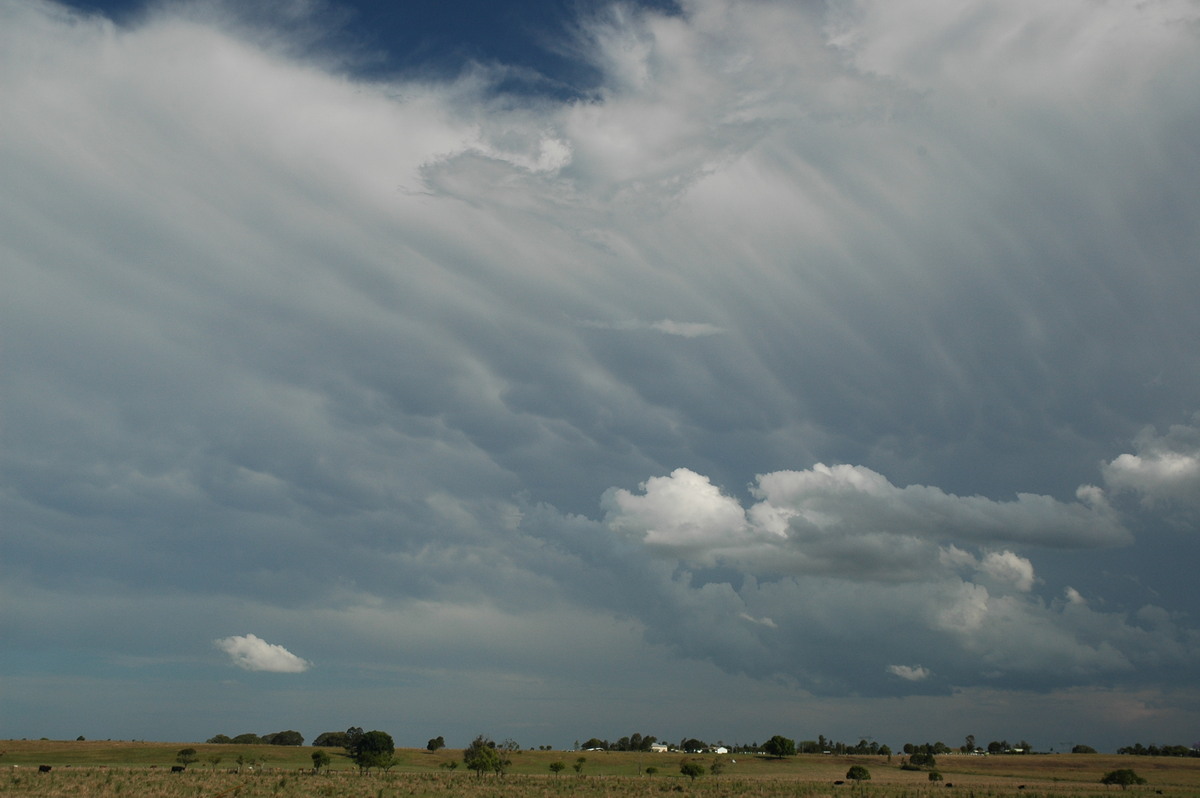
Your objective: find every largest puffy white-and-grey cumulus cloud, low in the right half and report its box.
[602,463,1130,578]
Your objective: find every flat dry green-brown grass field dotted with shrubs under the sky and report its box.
[0,740,1200,798]
